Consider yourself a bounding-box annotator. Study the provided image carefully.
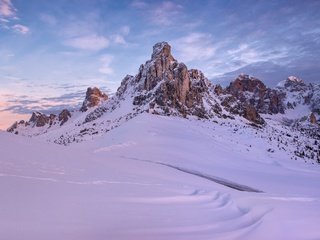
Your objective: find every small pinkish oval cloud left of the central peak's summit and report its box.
[64,34,109,51]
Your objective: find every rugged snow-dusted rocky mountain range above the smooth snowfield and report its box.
[8,42,320,162]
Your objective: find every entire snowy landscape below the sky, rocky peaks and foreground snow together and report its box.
[0,42,320,240]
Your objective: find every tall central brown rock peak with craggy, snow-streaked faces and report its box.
[123,42,220,118]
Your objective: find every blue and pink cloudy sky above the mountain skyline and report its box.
[0,0,320,129]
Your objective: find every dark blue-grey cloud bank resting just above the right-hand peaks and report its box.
[211,62,320,87]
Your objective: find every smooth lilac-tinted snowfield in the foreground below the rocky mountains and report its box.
[0,113,320,240]
